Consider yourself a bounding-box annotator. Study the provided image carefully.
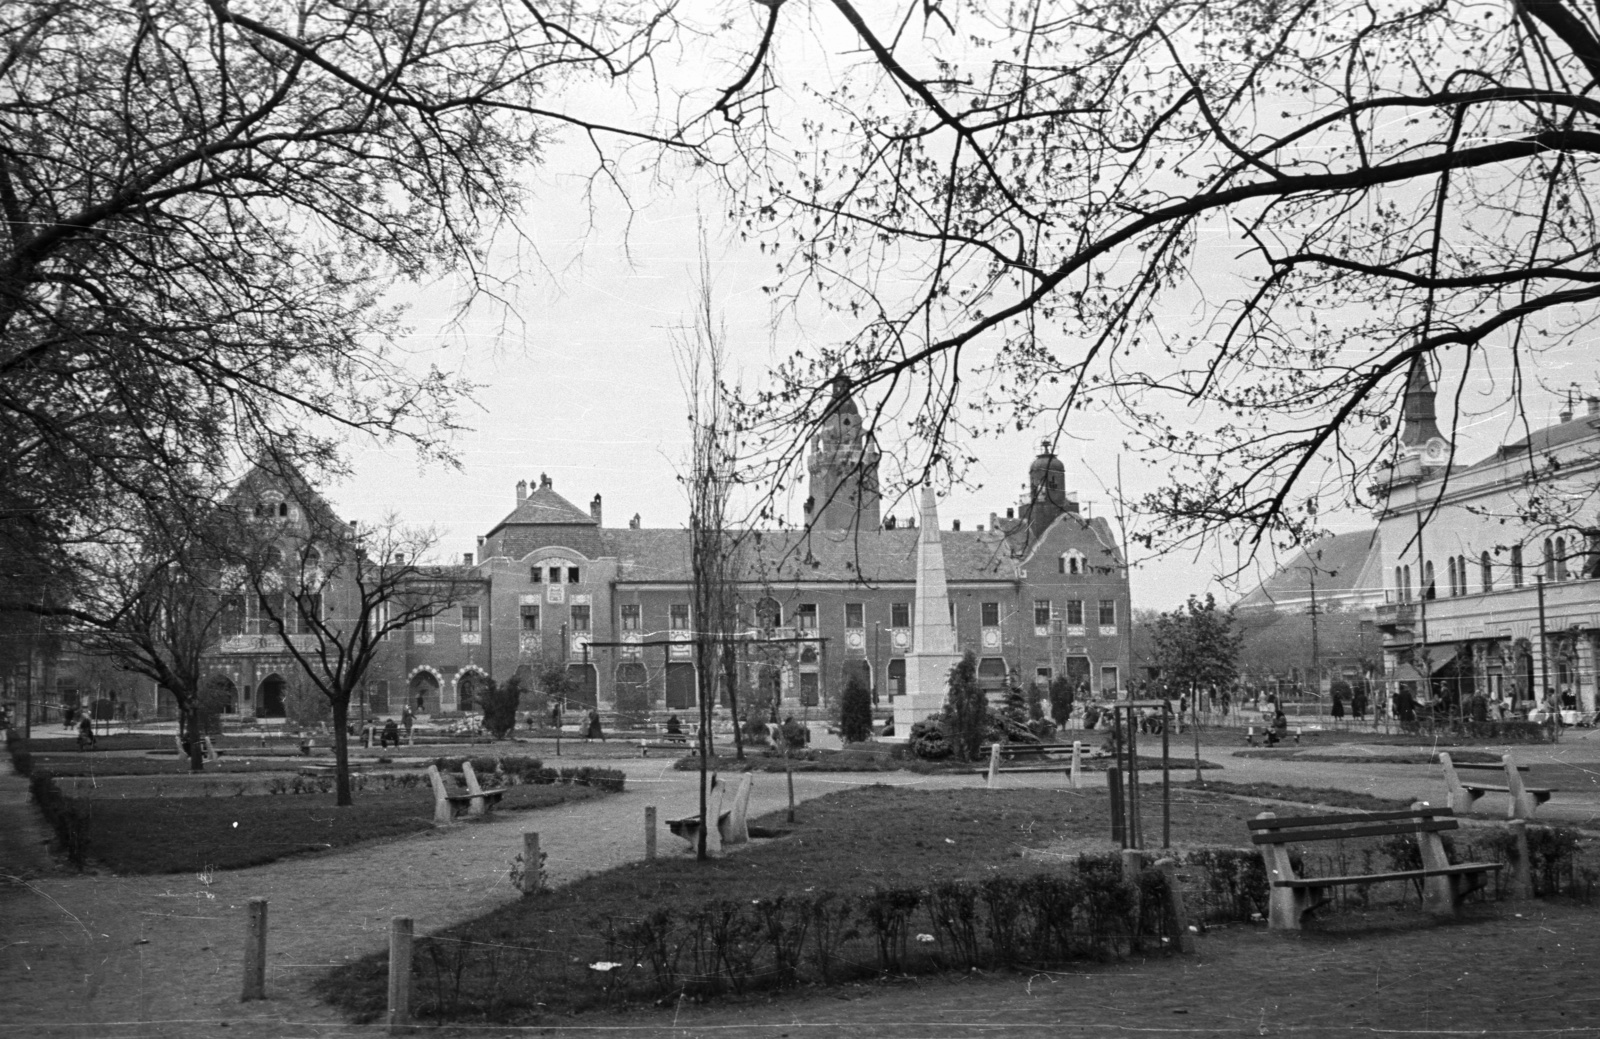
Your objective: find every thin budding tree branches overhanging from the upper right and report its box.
[707,0,1600,560]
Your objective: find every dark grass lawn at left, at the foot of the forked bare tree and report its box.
[51,784,605,874]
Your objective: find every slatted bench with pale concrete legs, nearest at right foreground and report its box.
[1246,802,1501,930]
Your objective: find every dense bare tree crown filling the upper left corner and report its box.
[0,0,674,608]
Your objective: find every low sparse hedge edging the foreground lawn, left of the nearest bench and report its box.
[334,855,1178,1021]
